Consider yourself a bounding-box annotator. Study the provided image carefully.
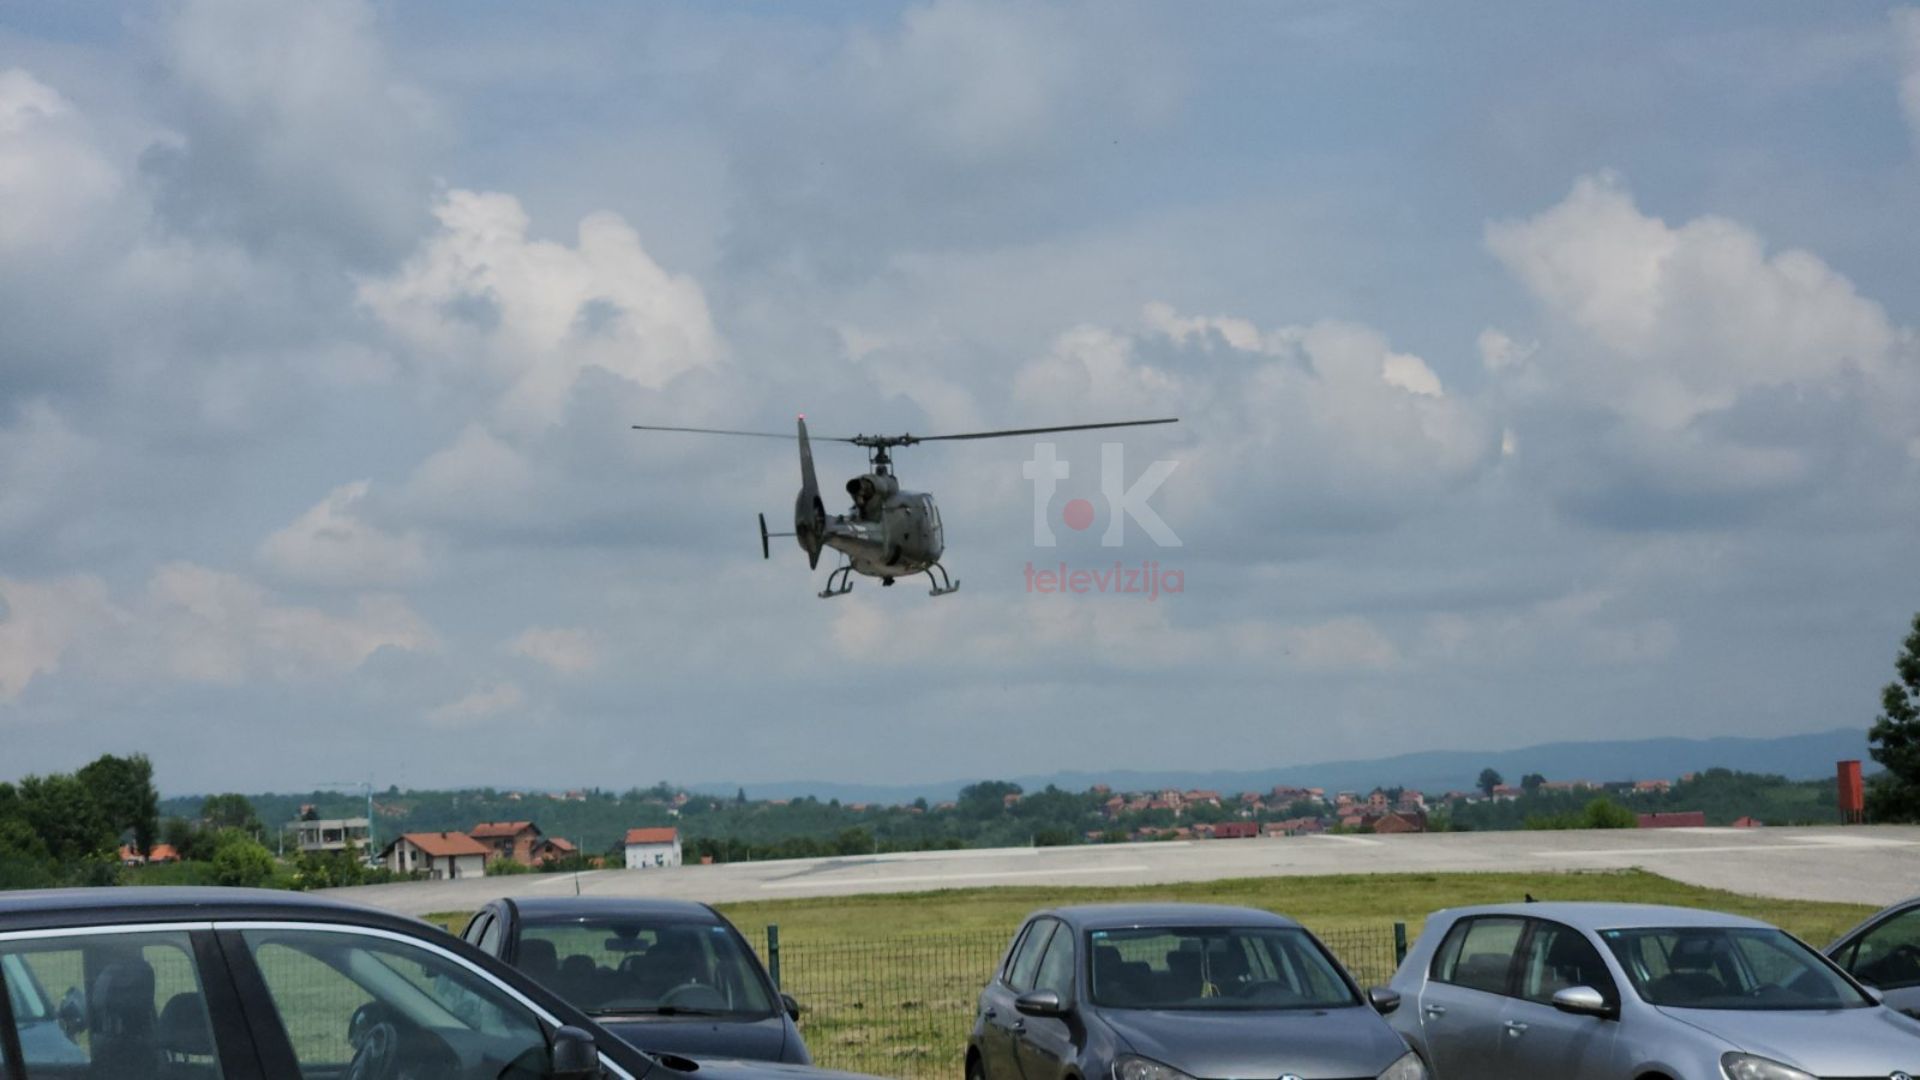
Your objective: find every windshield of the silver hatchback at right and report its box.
[1601,926,1872,1011]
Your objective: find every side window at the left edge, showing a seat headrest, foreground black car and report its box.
[0,930,221,1080]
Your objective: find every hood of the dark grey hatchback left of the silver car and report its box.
[1100,1005,1407,1076]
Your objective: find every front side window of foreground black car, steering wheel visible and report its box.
[240,930,549,1080]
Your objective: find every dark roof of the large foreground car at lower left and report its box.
[0,886,430,932]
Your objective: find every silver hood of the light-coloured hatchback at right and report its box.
[1661,1005,1920,1076]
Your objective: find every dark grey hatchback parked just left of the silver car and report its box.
[966,903,1427,1080]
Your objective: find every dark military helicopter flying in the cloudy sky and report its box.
[634,415,1179,600]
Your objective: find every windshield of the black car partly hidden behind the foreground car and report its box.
[518,919,774,1019]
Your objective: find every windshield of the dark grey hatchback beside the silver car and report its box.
[1089,926,1359,1011]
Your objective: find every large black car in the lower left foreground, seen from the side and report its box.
[0,888,871,1080]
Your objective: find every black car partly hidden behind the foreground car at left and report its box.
[461,896,812,1065]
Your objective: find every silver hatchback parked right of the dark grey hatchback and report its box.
[1388,903,1920,1080]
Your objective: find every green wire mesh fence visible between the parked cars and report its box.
[756,924,1407,1080]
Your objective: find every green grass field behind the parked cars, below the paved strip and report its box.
[428,871,1872,1078]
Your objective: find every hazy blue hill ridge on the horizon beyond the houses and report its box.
[691,728,1868,803]
